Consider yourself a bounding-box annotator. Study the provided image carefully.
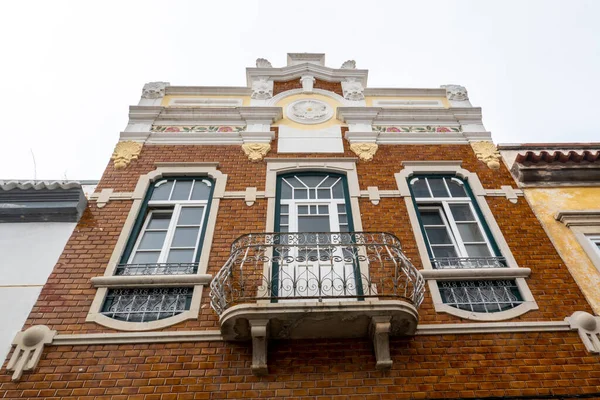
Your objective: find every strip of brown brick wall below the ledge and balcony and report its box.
[0,332,600,400]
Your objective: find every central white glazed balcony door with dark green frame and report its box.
[272,173,361,300]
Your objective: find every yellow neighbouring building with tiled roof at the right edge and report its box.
[499,143,600,315]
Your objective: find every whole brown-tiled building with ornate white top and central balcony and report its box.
[0,53,600,400]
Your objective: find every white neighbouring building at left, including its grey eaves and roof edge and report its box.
[0,180,97,360]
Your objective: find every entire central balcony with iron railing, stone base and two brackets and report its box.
[210,232,425,374]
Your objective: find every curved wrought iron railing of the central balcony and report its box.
[210,232,425,315]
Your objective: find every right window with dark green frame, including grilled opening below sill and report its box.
[409,175,523,313]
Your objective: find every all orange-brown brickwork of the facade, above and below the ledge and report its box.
[5,130,600,400]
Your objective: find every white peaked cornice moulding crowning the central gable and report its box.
[246,63,369,87]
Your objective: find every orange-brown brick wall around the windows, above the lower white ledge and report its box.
[21,141,591,333]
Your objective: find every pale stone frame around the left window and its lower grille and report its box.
[86,162,227,331]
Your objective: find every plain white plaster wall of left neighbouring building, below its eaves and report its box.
[0,222,76,360]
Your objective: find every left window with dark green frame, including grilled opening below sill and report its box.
[101,177,214,322]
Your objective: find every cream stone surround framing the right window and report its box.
[394,161,539,321]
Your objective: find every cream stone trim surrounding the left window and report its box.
[86,162,227,331]
